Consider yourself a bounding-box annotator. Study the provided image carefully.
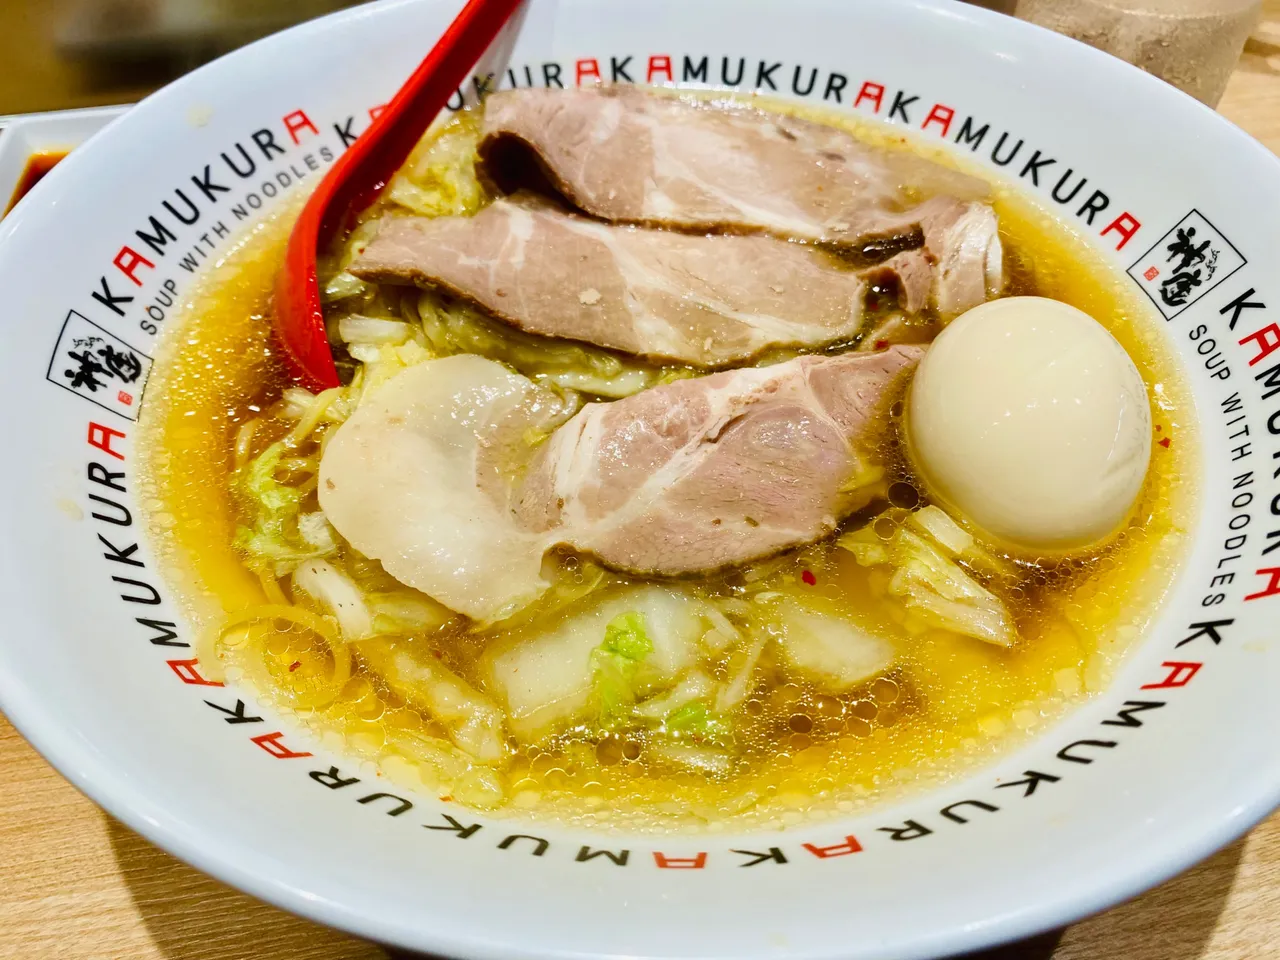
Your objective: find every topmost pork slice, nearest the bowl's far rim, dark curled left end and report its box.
[479,86,988,262]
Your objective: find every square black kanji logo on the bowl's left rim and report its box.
[45,310,151,420]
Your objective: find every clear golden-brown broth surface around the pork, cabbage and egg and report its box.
[142,96,1197,831]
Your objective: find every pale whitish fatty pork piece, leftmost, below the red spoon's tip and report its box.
[317,355,563,620]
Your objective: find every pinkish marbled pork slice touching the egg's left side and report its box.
[517,346,924,576]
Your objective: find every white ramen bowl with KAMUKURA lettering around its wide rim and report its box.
[0,0,1280,960]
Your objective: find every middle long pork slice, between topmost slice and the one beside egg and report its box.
[351,195,867,367]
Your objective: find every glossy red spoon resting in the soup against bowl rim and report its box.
[275,0,524,392]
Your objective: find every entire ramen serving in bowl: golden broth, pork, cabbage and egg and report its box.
[142,88,1194,829]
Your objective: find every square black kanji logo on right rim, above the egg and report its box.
[1129,210,1247,320]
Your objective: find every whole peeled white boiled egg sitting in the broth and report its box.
[906,297,1151,552]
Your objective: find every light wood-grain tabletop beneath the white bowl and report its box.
[0,9,1280,960]
